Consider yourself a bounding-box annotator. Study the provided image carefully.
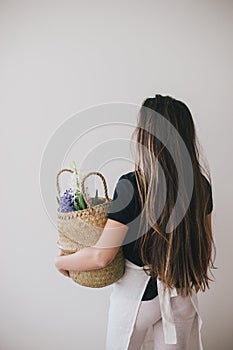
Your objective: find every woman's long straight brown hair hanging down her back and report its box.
[132,95,216,296]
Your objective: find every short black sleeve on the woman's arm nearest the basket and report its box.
[107,175,137,225]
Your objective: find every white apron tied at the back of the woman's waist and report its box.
[105,259,203,350]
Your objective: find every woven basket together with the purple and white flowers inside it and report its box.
[57,162,125,288]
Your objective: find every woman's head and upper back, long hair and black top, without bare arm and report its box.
[108,95,215,295]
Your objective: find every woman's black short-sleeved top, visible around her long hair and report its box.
[107,171,213,300]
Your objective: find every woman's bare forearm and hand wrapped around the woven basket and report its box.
[54,219,128,272]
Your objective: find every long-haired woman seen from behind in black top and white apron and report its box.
[55,95,215,350]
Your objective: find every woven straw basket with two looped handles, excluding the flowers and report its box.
[57,169,125,288]
